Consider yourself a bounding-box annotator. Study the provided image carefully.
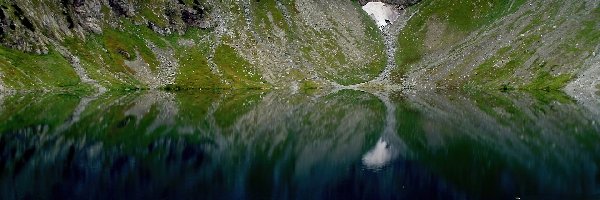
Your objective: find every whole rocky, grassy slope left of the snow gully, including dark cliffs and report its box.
[0,0,386,90]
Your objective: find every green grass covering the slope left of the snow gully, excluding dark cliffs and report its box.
[0,0,385,90]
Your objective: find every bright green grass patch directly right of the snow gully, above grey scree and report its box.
[392,0,525,82]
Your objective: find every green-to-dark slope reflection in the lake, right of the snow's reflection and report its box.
[400,94,600,196]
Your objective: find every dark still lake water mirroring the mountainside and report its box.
[0,90,600,200]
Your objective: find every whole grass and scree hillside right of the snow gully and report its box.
[392,0,600,90]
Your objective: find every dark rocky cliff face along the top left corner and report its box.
[0,0,210,54]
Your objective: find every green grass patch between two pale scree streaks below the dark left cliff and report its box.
[63,20,185,90]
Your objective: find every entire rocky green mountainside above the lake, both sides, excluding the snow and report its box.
[0,0,600,94]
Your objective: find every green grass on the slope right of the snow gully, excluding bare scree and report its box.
[394,0,600,90]
